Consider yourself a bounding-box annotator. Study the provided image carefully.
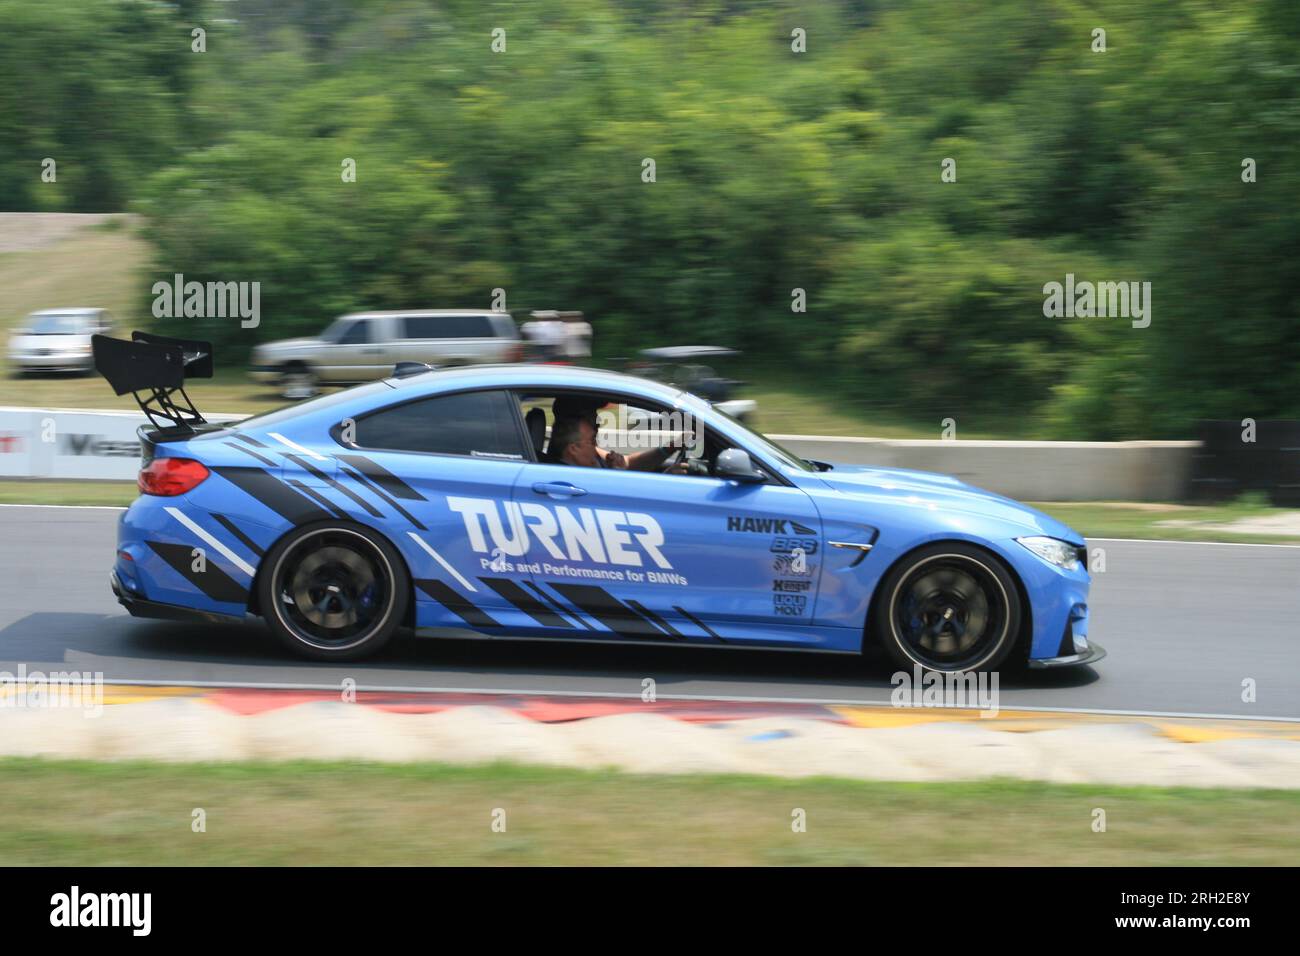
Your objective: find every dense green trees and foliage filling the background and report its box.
[0,0,1300,438]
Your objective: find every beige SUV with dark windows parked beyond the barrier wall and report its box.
[250,308,523,398]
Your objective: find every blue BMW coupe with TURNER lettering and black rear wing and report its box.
[94,333,1104,672]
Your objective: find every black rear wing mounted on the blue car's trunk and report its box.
[90,332,212,437]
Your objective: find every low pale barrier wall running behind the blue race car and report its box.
[0,406,1199,501]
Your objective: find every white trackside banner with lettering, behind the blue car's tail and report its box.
[0,406,246,481]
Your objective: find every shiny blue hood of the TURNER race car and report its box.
[816,464,1084,545]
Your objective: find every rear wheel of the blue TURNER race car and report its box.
[257,524,411,661]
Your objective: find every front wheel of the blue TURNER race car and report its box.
[871,542,1021,672]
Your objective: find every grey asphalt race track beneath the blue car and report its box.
[0,506,1300,719]
